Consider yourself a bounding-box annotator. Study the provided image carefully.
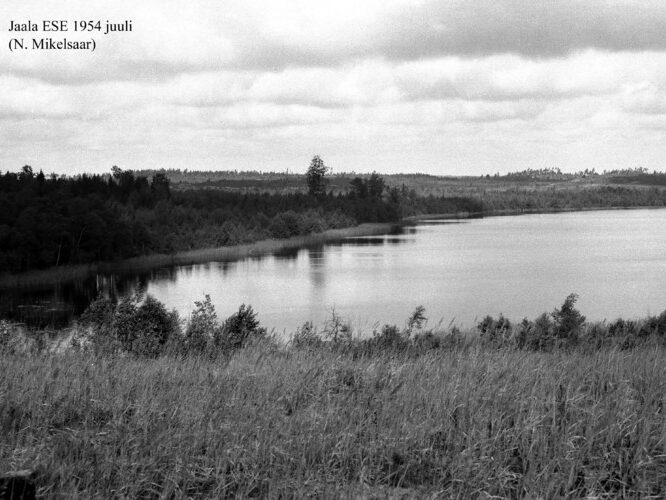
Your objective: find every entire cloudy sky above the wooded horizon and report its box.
[0,0,666,175]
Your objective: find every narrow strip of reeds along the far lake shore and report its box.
[0,206,664,290]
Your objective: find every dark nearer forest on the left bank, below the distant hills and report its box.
[0,166,481,273]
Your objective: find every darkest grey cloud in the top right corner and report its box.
[366,0,666,59]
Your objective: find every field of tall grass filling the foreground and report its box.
[0,345,666,498]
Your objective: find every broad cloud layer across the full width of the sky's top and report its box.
[5,0,666,84]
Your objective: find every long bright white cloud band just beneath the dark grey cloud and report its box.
[160,51,666,108]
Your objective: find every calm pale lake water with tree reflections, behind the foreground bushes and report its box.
[3,210,666,333]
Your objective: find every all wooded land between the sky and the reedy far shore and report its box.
[0,162,666,275]
